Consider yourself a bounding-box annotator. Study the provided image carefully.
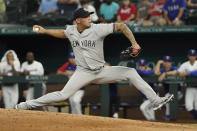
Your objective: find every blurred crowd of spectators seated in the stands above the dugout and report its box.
[0,0,197,26]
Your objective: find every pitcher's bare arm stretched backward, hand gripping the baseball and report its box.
[33,25,67,39]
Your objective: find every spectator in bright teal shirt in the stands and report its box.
[100,0,119,23]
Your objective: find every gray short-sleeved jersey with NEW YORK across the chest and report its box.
[64,24,114,70]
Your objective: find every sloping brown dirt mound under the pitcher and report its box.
[0,109,197,131]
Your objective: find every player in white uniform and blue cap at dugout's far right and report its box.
[178,49,197,120]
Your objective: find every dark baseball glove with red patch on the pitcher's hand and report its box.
[120,47,141,61]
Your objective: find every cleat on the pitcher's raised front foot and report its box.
[153,94,174,111]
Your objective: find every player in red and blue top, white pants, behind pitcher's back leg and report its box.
[56,52,85,114]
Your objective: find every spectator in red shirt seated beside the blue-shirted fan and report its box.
[143,0,166,26]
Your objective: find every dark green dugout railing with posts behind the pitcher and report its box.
[0,75,197,120]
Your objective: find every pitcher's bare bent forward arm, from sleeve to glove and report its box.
[115,23,141,49]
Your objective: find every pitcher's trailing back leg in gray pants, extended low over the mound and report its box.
[16,70,95,110]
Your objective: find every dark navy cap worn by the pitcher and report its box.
[74,8,94,20]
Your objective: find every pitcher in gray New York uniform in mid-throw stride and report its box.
[16,8,173,110]
